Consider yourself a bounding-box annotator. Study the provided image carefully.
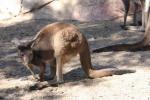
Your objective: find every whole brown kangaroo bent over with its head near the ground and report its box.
[18,22,135,83]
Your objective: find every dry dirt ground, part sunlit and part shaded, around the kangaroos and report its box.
[0,19,150,100]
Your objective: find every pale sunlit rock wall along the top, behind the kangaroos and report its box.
[0,0,124,21]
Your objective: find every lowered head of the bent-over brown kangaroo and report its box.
[18,42,33,65]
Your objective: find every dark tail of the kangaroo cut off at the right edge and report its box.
[93,12,150,53]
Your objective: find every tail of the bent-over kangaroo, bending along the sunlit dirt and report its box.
[79,34,135,78]
